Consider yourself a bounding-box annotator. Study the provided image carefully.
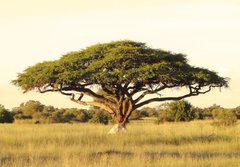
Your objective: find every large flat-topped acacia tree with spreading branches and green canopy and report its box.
[12,40,228,128]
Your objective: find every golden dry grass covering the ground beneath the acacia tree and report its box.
[0,121,240,167]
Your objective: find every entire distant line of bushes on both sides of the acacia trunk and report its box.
[0,100,240,125]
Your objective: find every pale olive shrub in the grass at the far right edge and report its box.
[213,108,237,126]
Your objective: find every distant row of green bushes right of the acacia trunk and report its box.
[132,100,240,125]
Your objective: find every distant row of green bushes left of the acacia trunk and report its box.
[0,100,111,124]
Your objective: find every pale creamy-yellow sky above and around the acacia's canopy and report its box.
[0,0,240,109]
